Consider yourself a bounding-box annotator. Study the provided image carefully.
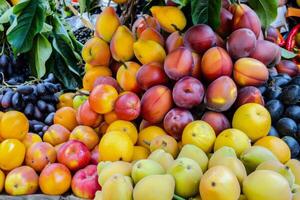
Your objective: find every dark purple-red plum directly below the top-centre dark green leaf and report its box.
[184,24,217,54]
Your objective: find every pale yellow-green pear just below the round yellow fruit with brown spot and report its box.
[177,144,208,172]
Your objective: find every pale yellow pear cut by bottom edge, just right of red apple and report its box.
[102,174,133,200]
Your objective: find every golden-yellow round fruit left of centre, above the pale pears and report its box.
[99,131,133,162]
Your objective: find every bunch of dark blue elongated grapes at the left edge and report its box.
[0,73,61,137]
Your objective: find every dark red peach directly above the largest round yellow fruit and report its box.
[236,86,265,107]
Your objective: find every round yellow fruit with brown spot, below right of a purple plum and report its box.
[182,120,216,153]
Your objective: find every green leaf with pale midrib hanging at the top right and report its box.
[248,0,278,28]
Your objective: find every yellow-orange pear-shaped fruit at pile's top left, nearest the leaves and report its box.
[95,7,120,42]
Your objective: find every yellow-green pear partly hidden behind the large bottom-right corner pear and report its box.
[240,146,278,174]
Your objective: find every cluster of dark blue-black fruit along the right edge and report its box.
[259,74,300,158]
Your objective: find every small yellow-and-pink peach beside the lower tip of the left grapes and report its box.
[43,124,71,146]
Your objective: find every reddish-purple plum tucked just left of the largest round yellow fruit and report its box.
[201,111,230,135]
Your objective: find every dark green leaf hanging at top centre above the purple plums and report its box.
[191,0,222,29]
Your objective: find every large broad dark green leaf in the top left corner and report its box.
[7,0,46,54]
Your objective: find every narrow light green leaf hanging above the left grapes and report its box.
[32,34,52,78]
